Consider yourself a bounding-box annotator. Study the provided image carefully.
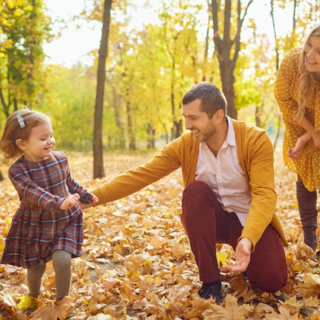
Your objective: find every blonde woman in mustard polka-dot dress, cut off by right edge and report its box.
[274,25,320,252]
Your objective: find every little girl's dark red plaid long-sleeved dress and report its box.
[1,152,93,269]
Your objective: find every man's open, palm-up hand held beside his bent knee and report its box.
[222,238,252,272]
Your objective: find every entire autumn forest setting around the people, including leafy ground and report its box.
[0,0,320,320]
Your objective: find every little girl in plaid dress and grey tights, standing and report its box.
[0,110,98,314]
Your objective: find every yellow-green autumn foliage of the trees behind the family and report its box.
[0,0,317,150]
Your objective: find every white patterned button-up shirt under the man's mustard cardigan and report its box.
[195,117,251,226]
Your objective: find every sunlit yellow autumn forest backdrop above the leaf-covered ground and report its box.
[0,0,320,174]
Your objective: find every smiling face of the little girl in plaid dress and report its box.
[16,122,55,161]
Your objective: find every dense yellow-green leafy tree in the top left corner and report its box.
[0,0,52,116]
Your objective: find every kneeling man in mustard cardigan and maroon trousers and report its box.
[84,82,288,303]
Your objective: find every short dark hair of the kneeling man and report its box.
[182,81,227,119]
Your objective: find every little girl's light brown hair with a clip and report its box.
[0,109,51,163]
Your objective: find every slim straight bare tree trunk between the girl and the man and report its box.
[93,0,112,179]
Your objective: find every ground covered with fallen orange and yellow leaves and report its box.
[0,153,320,320]
